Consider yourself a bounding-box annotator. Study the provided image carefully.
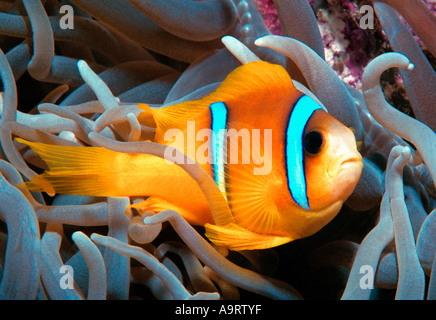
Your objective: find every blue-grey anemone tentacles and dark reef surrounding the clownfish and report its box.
[0,0,436,300]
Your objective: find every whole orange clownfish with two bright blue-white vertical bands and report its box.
[16,61,363,250]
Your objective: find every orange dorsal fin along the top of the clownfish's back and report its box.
[138,61,296,141]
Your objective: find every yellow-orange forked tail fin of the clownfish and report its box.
[16,138,119,196]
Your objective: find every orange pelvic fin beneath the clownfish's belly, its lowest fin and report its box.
[205,223,294,251]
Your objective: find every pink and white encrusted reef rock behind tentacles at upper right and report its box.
[255,0,436,88]
